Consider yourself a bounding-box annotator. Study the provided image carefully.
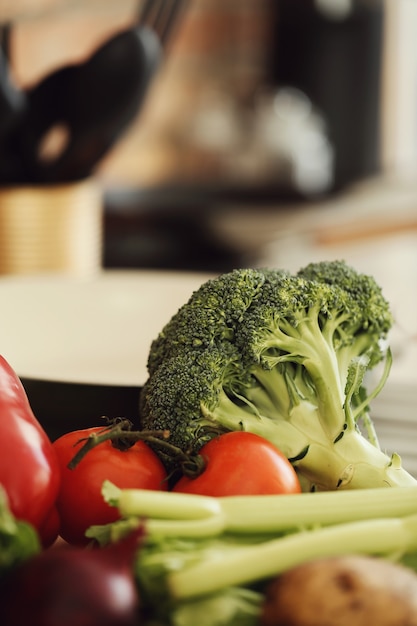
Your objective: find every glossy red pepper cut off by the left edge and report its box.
[0,356,60,531]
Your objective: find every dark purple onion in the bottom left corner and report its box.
[0,528,143,626]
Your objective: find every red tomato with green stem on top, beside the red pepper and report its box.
[54,427,168,545]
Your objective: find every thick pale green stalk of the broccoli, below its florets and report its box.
[206,386,417,491]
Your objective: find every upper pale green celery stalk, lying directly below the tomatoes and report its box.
[103,481,417,537]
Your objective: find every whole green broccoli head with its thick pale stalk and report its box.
[140,261,415,490]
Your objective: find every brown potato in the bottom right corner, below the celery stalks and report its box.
[260,555,417,626]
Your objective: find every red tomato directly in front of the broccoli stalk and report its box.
[173,431,301,497]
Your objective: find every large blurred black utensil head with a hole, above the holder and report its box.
[14,28,161,183]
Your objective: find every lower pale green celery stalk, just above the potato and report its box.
[167,515,417,601]
